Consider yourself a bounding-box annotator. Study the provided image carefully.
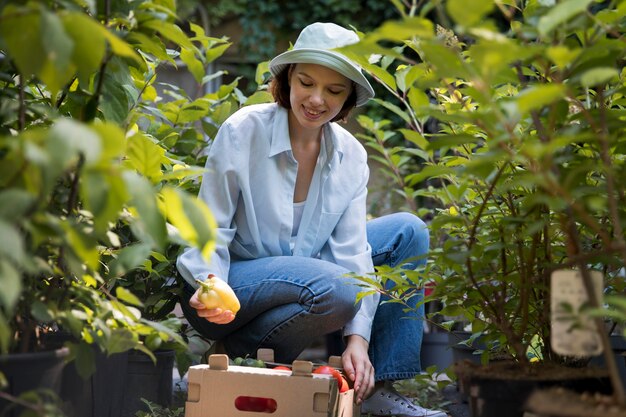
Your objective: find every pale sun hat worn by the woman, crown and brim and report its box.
[269,22,374,107]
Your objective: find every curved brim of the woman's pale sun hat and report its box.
[269,48,374,107]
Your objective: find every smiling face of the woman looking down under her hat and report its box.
[289,64,353,128]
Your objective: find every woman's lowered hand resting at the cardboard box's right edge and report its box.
[341,334,374,404]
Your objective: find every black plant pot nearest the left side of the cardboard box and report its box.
[119,350,174,417]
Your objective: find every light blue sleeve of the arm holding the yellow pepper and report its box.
[176,124,240,287]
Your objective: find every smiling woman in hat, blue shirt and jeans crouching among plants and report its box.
[177,23,446,417]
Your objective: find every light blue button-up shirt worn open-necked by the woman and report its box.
[177,103,379,341]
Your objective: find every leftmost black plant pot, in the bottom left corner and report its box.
[0,348,69,417]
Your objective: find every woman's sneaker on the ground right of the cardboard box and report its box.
[361,386,448,417]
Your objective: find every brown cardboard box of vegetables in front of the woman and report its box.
[185,354,360,417]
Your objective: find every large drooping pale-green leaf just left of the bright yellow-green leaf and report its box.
[124,172,167,250]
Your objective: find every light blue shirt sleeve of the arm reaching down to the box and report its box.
[320,165,380,342]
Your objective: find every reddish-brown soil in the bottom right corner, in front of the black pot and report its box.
[527,388,626,417]
